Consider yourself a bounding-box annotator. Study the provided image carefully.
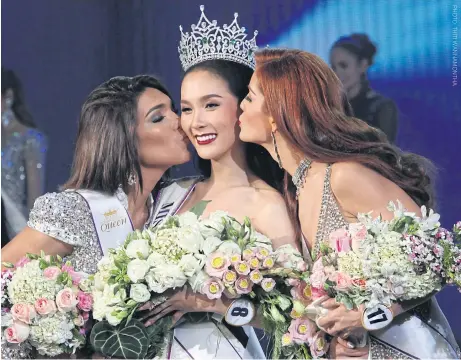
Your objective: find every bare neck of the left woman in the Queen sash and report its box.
[127,169,166,219]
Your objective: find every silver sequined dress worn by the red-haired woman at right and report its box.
[303,165,461,359]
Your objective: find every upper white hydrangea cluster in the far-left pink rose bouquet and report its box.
[8,260,64,304]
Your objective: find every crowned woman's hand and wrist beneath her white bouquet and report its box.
[139,286,227,327]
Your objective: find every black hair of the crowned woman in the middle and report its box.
[184,60,284,191]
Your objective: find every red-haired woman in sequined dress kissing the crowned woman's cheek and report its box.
[240,49,459,358]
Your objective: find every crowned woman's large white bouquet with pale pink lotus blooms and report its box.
[91,211,307,358]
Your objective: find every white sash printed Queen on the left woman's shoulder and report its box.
[76,190,134,255]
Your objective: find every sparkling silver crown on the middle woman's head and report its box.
[178,5,258,71]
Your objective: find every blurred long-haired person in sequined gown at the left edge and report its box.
[1,67,47,247]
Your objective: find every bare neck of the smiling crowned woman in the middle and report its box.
[208,146,251,189]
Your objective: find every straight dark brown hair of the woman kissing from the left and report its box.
[63,75,171,194]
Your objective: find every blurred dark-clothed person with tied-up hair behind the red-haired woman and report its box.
[330,34,398,143]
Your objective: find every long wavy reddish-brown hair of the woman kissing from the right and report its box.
[256,49,434,232]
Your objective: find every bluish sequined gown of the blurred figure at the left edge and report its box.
[2,129,47,238]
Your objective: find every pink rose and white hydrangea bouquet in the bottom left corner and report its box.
[1,252,93,358]
